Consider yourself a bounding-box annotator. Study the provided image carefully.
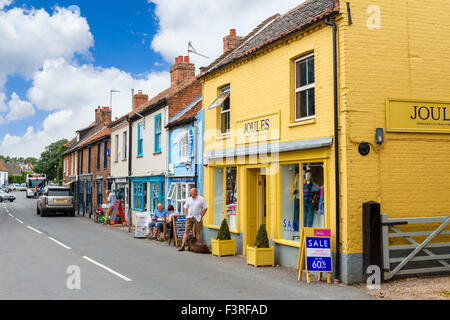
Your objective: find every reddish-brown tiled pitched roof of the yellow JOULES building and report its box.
[201,0,340,76]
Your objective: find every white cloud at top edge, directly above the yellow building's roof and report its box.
[148,0,303,67]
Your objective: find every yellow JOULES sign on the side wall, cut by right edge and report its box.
[386,99,450,133]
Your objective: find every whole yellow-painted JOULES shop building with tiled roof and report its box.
[201,0,450,282]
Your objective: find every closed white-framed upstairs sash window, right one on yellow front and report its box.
[295,54,316,121]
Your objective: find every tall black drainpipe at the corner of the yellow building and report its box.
[325,18,341,279]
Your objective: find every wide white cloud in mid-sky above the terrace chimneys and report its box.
[28,58,170,116]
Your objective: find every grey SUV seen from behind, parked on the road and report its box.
[36,186,75,217]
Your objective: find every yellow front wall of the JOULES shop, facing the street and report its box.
[203,25,335,251]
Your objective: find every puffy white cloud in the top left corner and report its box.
[0,5,94,77]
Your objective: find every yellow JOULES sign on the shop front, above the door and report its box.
[236,112,280,144]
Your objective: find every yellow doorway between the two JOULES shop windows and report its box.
[247,168,267,246]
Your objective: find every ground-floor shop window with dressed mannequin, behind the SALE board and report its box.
[281,163,325,241]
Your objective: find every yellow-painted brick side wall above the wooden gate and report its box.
[339,0,450,253]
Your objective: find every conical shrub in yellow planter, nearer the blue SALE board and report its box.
[247,224,275,267]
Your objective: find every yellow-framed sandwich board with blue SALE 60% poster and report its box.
[297,228,333,284]
